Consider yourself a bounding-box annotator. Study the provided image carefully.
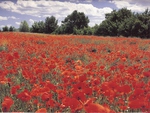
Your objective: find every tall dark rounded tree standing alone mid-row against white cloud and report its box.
[62,10,89,34]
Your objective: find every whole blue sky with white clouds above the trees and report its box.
[0,0,150,28]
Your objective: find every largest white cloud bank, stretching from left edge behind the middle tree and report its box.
[0,0,112,25]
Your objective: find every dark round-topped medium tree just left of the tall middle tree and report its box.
[45,16,58,33]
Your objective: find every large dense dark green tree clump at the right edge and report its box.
[95,8,150,38]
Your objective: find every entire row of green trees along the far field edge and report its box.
[3,8,150,38]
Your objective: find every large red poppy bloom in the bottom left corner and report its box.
[2,97,14,112]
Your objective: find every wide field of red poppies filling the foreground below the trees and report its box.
[0,32,150,113]
